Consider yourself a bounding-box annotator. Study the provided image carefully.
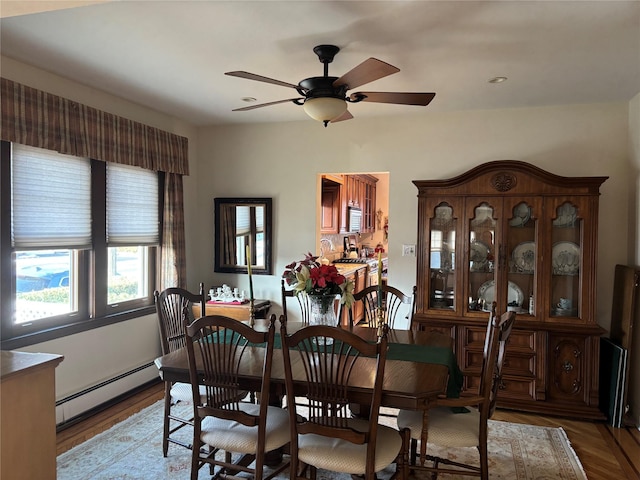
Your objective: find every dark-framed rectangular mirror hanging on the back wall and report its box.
[214,198,273,275]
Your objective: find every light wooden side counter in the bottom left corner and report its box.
[0,351,64,480]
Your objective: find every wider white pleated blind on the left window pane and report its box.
[11,143,91,249]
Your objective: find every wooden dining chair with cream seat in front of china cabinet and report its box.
[398,302,516,480]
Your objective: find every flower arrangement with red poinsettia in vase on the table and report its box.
[282,253,354,307]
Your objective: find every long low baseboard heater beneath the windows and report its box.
[56,362,160,431]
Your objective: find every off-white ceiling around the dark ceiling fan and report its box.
[0,0,640,127]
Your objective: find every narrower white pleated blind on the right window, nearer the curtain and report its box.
[107,163,160,246]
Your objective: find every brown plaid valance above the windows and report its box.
[0,78,189,175]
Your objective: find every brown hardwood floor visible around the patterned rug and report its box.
[57,383,640,480]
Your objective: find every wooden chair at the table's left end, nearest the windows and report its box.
[154,283,206,457]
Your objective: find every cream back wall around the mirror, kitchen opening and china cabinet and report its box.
[195,104,629,334]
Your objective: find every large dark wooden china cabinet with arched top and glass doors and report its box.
[413,160,607,419]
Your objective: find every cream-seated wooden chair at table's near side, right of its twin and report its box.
[280,316,409,480]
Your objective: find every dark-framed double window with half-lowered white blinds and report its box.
[0,142,161,347]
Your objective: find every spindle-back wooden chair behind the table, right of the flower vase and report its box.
[338,285,417,328]
